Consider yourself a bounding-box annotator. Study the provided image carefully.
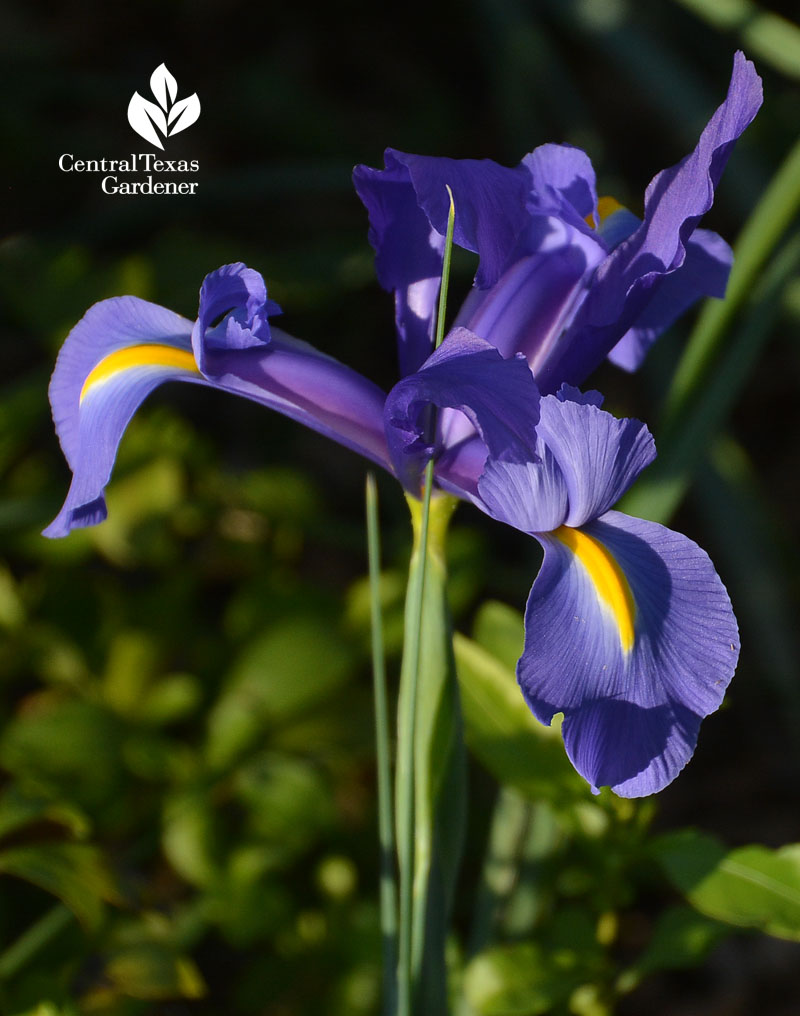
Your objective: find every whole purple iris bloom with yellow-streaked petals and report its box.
[46,54,760,797]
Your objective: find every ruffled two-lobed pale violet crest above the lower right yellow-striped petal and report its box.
[477,386,656,534]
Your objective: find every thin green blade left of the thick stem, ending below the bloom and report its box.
[366,472,397,1016]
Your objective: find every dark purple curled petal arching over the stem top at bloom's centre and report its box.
[385,328,539,494]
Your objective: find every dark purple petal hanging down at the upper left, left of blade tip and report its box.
[353,156,444,376]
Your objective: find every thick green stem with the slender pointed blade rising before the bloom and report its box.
[395,187,464,1016]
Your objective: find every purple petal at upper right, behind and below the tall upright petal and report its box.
[608,230,733,371]
